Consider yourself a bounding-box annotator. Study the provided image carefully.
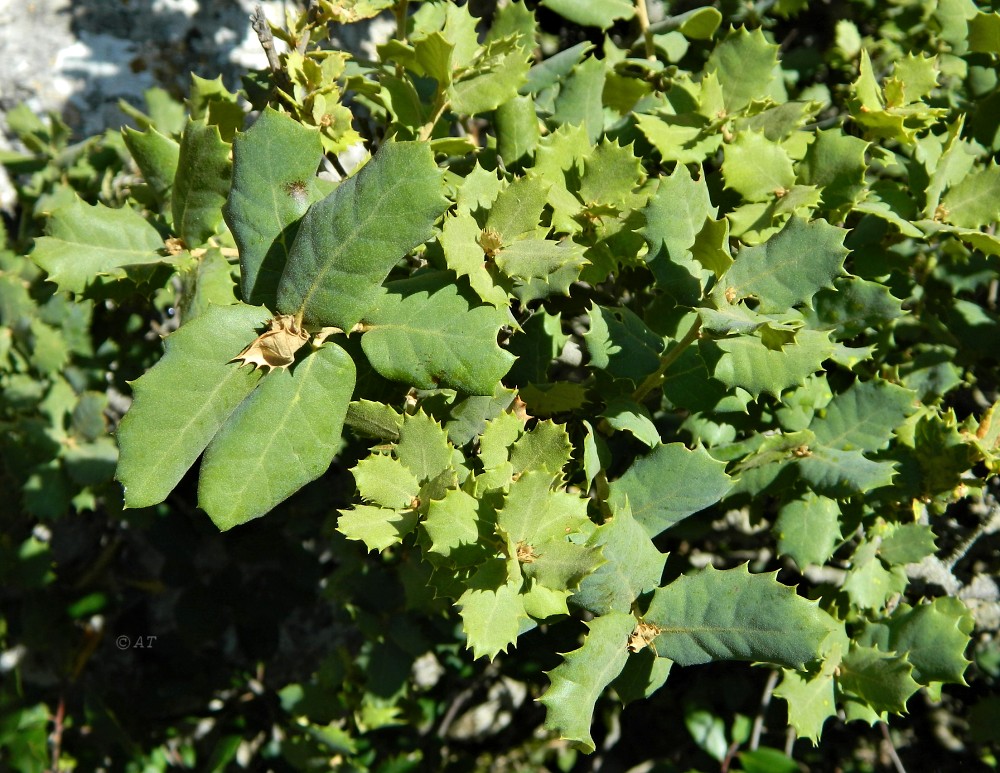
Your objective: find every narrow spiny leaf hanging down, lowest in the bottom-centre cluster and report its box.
[538,612,635,752]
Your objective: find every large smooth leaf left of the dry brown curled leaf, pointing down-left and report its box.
[115,304,269,507]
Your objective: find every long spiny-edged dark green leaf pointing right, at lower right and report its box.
[643,564,840,668]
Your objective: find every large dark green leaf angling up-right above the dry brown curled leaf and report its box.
[278,142,446,326]
